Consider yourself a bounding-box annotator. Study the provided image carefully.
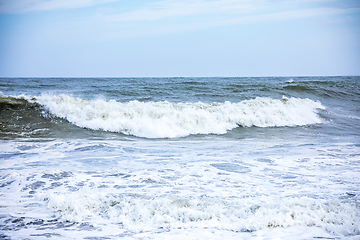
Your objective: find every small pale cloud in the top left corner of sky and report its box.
[0,0,117,13]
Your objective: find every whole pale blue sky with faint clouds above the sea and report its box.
[0,0,360,77]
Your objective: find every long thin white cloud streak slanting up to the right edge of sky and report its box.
[88,5,360,40]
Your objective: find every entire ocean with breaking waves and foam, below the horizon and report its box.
[0,76,360,240]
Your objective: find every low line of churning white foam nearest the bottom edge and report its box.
[47,192,360,236]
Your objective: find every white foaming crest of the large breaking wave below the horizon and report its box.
[36,95,324,138]
